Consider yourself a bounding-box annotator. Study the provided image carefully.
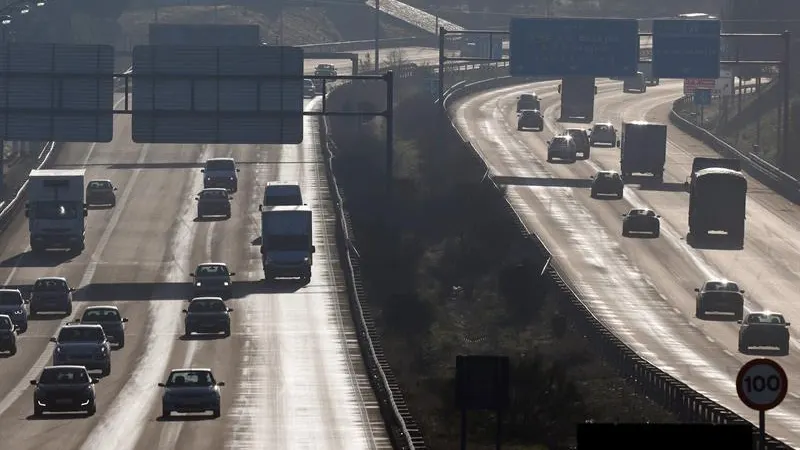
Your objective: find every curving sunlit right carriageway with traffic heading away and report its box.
[451,79,800,447]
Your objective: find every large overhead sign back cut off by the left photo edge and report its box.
[0,43,114,142]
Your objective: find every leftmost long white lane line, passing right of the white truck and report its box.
[0,139,149,415]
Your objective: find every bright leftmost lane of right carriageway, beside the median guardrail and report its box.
[456,85,790,446]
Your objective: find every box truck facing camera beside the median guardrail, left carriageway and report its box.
[261,205,316,284]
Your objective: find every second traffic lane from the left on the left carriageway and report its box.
[0,139,216,448]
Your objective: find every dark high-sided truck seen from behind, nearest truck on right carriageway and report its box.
[687,158,747,247]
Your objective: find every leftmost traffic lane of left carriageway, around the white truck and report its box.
[0,106,152,415]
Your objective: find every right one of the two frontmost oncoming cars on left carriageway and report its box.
[158,369,225,417]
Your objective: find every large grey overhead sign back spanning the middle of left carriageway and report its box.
[132,45,303,144]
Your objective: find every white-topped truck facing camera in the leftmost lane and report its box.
[25,169,89,252]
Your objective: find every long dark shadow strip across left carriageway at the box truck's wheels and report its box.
[73,281,302,303]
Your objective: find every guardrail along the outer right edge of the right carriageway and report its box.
[669,92,800,202]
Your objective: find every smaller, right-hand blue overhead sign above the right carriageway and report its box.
[653,19,722,78]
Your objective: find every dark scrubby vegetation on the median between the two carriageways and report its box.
[329,72,674,449]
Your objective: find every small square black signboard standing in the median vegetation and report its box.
[456,355,511,411]
